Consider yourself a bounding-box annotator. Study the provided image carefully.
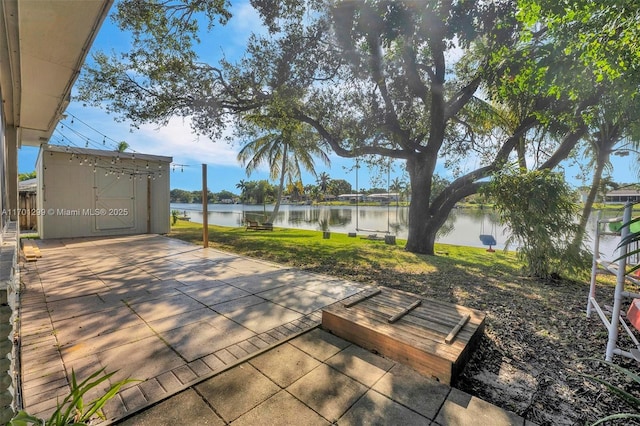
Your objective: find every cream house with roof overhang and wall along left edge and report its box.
[0,0,113,424]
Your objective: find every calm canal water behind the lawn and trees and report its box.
[171,203,622,259]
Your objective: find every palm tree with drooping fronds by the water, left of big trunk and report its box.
[238,122,331,222]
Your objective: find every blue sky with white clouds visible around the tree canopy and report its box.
[18,1,637,192]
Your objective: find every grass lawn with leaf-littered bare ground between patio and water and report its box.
[170,221,638,425]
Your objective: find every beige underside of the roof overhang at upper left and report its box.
[0,0,113,146]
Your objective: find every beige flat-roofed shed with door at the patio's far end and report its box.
[36,145,172,239]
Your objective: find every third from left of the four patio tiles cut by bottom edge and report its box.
[338,390,428,426]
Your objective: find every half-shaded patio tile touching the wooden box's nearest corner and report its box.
[373,364,450,419]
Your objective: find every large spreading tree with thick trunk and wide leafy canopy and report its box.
[80,0,640,254]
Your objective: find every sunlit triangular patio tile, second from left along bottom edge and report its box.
[233,391,330,426]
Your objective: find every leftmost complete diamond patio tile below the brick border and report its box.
[196,364,280,422]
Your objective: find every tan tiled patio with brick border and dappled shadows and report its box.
[20,235,530,425]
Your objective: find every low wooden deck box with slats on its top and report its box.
[322,288,485,384]
